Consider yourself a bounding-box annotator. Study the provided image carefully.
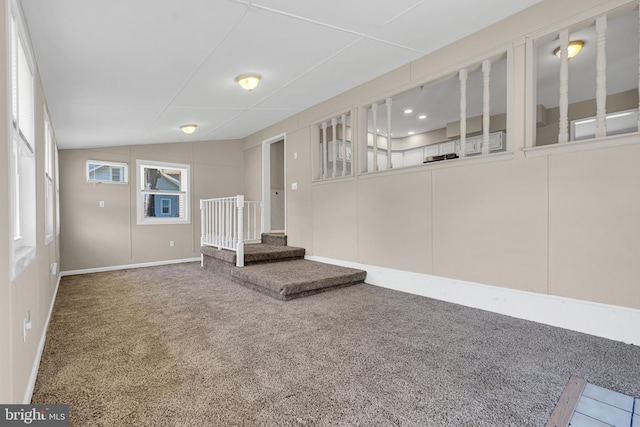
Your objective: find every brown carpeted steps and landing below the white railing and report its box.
[201,234,367,301]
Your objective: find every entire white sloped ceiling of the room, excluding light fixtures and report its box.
[22,0,540,149]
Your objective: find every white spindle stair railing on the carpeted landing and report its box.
[200,195,262,267]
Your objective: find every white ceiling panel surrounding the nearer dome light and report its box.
[172,9,358,108]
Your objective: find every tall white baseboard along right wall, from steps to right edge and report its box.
[305,256,640,345]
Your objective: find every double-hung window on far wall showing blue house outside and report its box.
[136,160,190,224]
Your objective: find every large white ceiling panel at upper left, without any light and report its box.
[23,0,246,105]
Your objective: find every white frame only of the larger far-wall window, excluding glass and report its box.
[136,159,191,225]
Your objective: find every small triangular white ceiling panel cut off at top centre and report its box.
[248,0,424,34]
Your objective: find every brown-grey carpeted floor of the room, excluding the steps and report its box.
[32,263,640,427]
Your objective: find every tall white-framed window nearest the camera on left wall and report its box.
[7,0,37,280]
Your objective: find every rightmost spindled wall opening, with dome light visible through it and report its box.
[532,3,639,146]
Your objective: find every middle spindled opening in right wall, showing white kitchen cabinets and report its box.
[360,54,507,172]
